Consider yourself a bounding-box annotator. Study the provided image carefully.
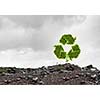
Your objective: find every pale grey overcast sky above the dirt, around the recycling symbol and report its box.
[0,15,100,68]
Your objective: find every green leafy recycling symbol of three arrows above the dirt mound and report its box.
[54,34,81,61]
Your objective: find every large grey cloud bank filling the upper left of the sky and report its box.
[0,15,86,51]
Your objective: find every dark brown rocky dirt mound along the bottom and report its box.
[0,63,100,85]
